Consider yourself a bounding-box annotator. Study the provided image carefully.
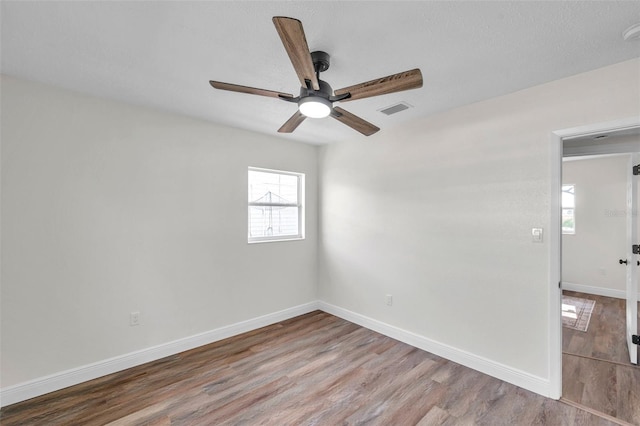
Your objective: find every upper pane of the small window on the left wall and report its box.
[249,170,298,204]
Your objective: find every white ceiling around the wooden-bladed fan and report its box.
[1,0,640,144]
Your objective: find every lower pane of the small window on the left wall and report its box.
[249,206,299,238]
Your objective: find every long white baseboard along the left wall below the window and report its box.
[0,302,319,407]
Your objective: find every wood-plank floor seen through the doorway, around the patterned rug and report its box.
[562,291,640,425]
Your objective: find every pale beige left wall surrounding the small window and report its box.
[1,76,317,388]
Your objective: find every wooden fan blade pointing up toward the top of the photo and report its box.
[273,16,320,90]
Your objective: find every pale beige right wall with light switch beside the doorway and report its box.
[319,60,640,381]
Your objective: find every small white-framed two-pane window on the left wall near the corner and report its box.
[248,167,304,243]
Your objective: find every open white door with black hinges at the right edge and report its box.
[627,153,640,364]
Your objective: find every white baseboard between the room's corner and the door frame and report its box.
[319,301,552,397]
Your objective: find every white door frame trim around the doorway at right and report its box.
[548,117,640,399]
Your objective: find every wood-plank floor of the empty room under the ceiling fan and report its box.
[0,311,613,426]
